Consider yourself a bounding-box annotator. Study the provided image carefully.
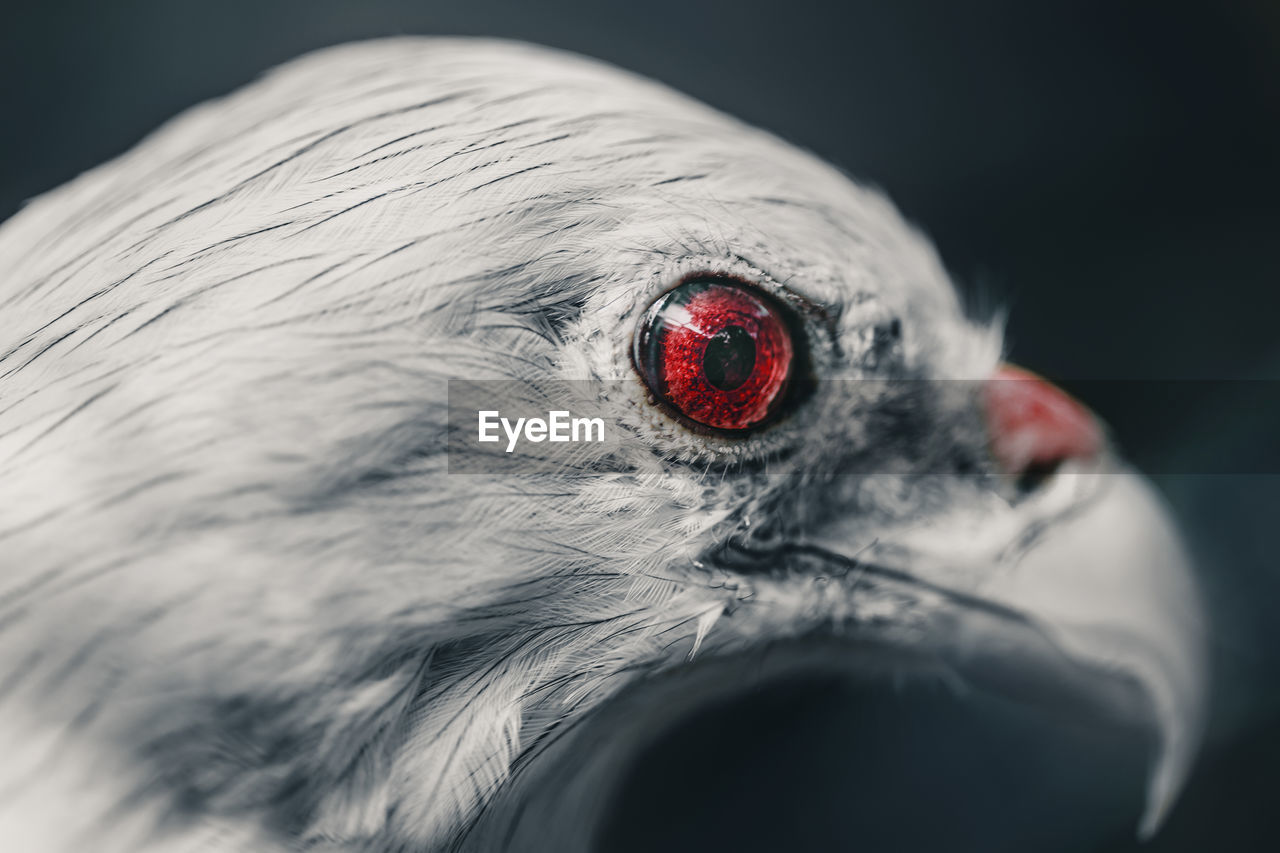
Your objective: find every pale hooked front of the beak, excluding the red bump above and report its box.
[956,470,1206,838]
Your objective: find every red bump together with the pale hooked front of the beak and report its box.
[983,365,1206,838]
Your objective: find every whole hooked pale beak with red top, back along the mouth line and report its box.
[812,366,1206,838]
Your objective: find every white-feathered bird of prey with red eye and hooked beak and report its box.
[0,36,1208,853]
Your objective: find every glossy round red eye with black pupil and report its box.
[635,280,792,430]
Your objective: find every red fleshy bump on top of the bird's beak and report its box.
[983,364,1103,479]
